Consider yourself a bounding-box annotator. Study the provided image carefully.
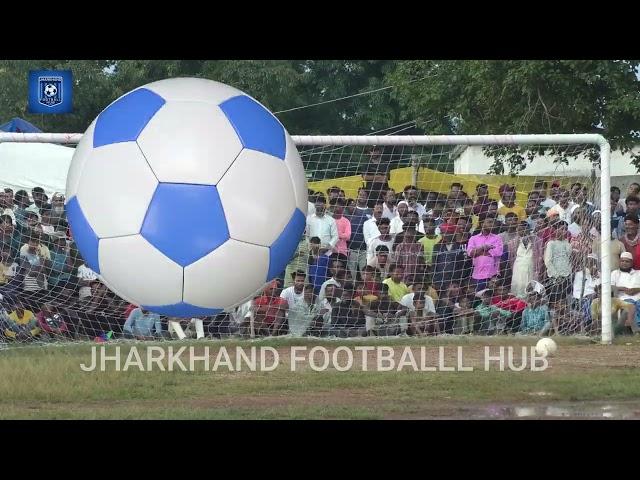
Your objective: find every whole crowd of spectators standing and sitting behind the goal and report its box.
[0,154,640,342]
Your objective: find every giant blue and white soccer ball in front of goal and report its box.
[66,78,307,317]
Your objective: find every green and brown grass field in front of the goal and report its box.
[0,337,640,419]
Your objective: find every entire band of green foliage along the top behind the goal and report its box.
[0,60,640,172]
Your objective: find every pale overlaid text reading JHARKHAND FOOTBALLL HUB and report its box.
[80,346,549,373]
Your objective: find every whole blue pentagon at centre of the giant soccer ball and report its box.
[140,183,229,267]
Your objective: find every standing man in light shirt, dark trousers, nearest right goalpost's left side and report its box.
[544,221,573,310]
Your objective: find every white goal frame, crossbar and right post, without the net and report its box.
[0,132,613,345]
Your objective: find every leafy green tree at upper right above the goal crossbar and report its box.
[386,60,640,173]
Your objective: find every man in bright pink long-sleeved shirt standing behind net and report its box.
[467,216,503,291]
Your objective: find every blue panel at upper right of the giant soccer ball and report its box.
[220,95,287,160]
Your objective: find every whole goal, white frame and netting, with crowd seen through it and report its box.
[0,134,620,344]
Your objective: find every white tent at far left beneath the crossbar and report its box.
[0,143,75,198]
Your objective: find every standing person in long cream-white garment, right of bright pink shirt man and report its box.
[507,222,544,298]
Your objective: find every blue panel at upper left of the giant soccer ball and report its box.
[93,88,165,148]
